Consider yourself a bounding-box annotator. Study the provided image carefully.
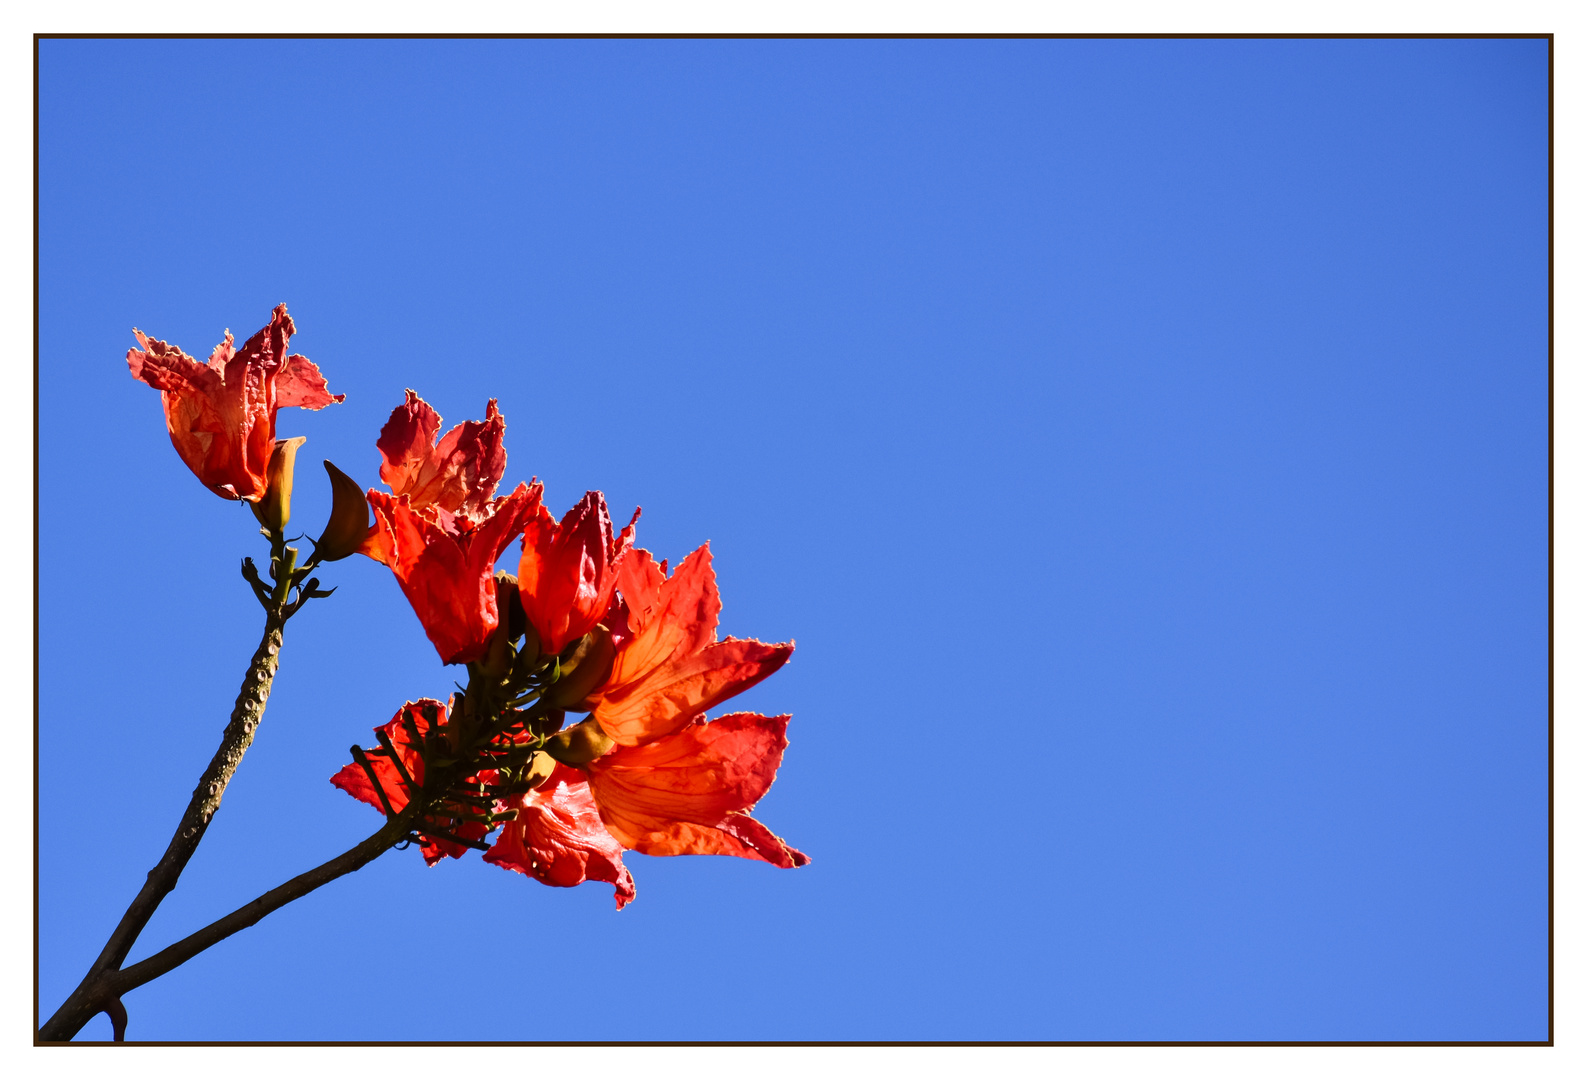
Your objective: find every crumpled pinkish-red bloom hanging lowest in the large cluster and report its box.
[484,764,635,910]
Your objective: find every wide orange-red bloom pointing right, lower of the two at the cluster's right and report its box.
[586,712,809,867]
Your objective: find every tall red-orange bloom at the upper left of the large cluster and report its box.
[359,390,543,664]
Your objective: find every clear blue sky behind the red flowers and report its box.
[40,40,1547,1039]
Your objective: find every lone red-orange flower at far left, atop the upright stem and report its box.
[127,304,346,501]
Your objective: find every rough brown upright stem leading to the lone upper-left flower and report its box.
[38,528,329,1042]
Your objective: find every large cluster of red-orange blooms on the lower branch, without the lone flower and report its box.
[335,402,809,909]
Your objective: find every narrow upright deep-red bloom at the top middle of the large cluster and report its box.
[517,492,640,653]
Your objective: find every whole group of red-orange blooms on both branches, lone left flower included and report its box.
[127,306,809,909]
